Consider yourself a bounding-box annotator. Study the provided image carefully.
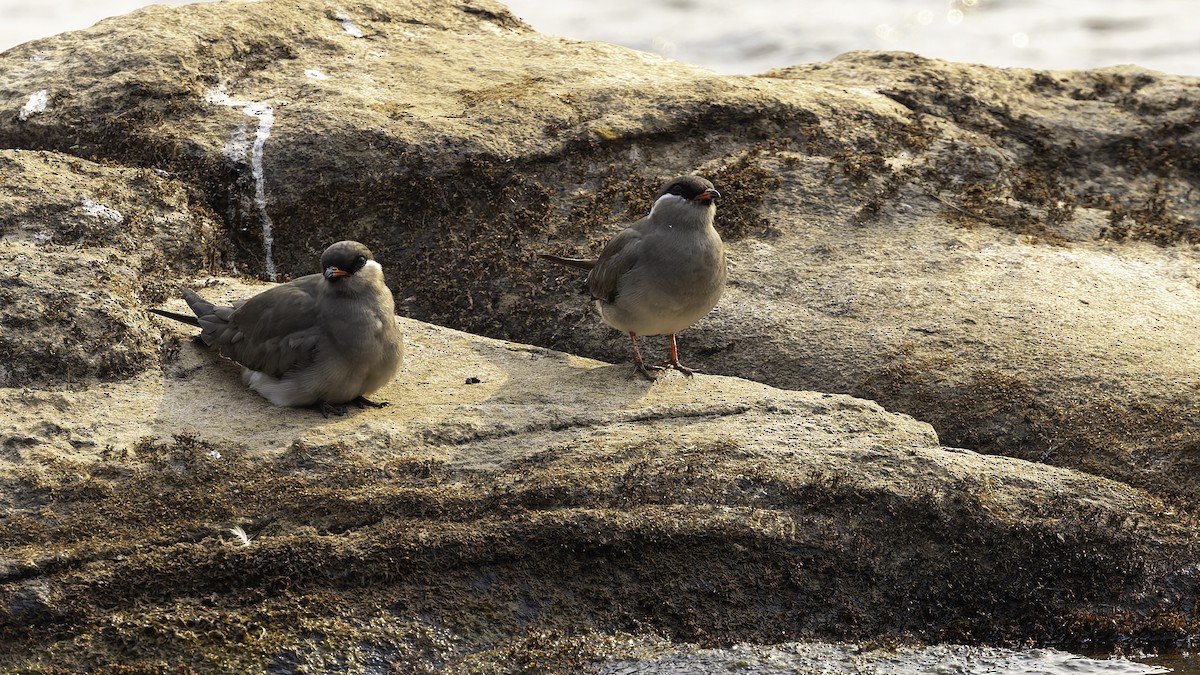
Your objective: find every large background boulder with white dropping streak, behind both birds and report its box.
[0,1,1200,498]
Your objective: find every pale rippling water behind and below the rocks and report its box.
[0,0,1200,674]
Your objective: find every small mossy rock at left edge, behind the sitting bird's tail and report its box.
[0,150,218,388]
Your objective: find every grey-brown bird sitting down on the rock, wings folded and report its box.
[150,240,404,414]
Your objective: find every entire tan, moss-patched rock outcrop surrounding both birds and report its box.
[0,0,1200,671]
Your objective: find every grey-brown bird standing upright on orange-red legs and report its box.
[539,175,728,382]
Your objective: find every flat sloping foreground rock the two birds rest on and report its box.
[0,280,1194,671]
